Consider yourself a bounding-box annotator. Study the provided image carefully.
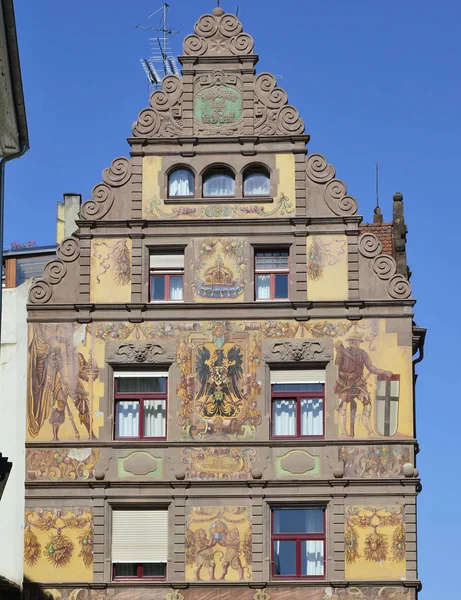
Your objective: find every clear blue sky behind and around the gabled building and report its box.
[5,0,461,600]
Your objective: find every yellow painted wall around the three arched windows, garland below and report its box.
[142,154,296,219]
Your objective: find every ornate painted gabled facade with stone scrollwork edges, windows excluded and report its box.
[25,8,424,600]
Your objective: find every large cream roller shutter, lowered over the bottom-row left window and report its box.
[112,510,168,563]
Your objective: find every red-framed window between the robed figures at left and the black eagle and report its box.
[114,371,168,440]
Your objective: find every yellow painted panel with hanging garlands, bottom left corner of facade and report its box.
[24,507,93,582]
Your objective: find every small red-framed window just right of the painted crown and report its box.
[255,250,289,300]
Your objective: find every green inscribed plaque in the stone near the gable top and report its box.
[195,85,242,127]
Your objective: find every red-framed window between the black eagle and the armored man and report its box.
[271,370,325,439]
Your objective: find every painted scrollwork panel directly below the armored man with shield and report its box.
[339,445,411,479]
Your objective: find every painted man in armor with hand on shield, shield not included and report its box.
[335,335,392,438]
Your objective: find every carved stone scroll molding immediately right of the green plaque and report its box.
[254,73,304,135]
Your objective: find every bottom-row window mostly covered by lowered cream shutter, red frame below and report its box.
[112,509,168,579]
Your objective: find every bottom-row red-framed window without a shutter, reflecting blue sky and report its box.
[272,506,325,579]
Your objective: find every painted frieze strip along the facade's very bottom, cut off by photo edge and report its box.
[38,585,416,600]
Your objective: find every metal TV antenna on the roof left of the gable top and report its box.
[136,2,181,89]
